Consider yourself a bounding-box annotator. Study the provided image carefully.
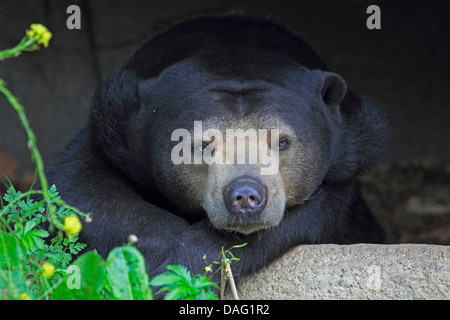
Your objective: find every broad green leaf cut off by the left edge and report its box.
[0,231,26,268]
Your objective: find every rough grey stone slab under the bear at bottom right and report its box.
[228,244,450,300]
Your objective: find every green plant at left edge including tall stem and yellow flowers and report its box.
[0,24,92,299]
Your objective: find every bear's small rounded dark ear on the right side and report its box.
[316,70,347,106]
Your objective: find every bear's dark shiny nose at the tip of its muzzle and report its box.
[223,177,267,214]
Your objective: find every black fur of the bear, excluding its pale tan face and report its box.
[47,15,388,284]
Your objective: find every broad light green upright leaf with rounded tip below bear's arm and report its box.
[106,246,153,300]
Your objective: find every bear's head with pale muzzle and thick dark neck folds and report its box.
[89,15,385,234]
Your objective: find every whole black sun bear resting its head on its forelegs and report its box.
[47,14,388,282]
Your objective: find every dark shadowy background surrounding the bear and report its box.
[0,0,450,244]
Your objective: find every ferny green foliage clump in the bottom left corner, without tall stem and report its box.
[0,182,86,299]
